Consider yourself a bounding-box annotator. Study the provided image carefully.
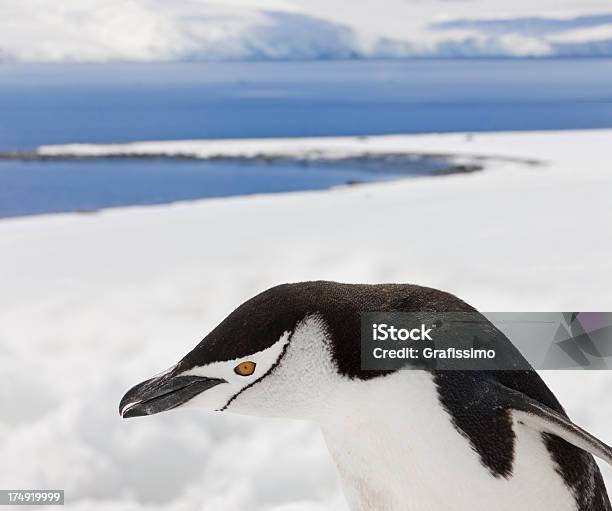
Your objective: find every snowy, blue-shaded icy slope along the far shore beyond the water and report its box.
[0,0,612,62]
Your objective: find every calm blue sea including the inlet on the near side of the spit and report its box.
[0,59,612,217]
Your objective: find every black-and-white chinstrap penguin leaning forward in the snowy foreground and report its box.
[119,282,612,511]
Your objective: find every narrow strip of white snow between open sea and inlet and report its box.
[36,130,612,161]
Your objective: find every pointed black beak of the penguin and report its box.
[119,372,226,419]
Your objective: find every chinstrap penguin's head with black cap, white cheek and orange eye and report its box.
[119,284,352,418]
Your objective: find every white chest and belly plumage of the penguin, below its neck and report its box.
[322,371,577,511]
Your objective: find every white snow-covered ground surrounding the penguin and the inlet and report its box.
[0,131,612,511]
